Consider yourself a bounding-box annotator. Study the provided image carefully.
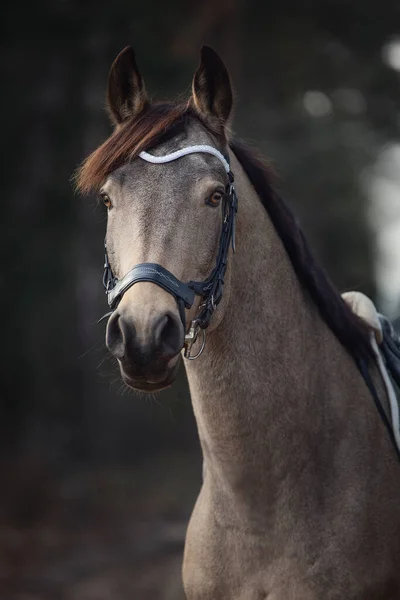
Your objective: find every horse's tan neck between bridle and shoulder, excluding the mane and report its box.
[186,154,359,524]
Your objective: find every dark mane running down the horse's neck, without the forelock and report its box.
[230,140,371,358]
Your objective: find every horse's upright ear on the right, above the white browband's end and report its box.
[191,46,232,127]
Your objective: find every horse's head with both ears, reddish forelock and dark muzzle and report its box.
[78,48,233,391]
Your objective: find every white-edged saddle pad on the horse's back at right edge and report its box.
[342,292,400,451]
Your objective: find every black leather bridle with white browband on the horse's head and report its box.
[103,145,238,360]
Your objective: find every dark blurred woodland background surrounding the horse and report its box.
[0,0,400,600]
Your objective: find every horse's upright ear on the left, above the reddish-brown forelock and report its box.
[107,46,148,125]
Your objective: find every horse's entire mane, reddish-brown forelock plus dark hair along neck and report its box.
[75,104,371,358]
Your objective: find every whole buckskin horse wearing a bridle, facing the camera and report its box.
[77,47,400,600]
